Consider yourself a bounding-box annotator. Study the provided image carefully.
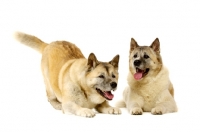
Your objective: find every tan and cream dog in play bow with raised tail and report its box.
[14,32,121,117]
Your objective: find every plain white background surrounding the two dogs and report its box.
[0,0,200,132]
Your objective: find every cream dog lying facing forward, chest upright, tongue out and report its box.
[116,38,177,115]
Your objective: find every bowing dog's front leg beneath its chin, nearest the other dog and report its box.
[95,101,121,114]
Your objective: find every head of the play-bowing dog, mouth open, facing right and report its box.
[86,53,119,100]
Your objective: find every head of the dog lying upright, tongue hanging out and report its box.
[129,38,162,81]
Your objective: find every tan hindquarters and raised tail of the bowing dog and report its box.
[14,32,85,106]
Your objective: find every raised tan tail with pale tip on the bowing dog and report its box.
[14,32,48,53]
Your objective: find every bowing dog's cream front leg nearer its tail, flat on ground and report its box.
[62,101,95,117]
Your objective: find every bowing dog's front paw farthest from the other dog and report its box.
[76,108,95,118]
